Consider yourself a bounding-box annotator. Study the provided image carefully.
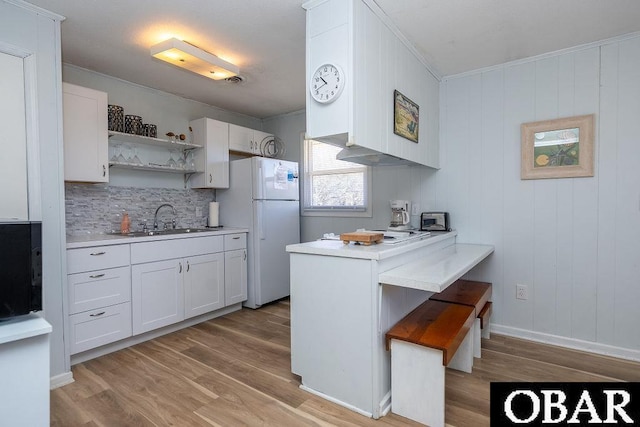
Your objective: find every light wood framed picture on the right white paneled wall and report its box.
[520,114,594,179]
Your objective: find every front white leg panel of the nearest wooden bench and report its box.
[391,340,444,427]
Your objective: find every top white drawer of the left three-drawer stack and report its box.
[67,245,130,274]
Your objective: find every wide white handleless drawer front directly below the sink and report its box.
[131,236,223,264]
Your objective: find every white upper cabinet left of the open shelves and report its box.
[62,83,109,182]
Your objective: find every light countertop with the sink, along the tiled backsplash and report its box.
[67,227,249,249]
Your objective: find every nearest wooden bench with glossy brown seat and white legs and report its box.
[386,300,476,427]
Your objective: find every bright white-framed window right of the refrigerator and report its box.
[303,139,371,216]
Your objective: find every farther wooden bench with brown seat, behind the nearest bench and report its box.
[429,279,492,358]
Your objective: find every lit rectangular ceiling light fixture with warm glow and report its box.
[151,38,240,80]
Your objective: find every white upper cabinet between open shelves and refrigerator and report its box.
[189,118,230,188]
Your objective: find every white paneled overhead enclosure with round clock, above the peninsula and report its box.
[306,0,440,168]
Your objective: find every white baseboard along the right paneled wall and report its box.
[491,322,640,362]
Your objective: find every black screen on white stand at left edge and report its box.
[0,221,42,319]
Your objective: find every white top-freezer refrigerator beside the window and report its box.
[216,157,300,308]
